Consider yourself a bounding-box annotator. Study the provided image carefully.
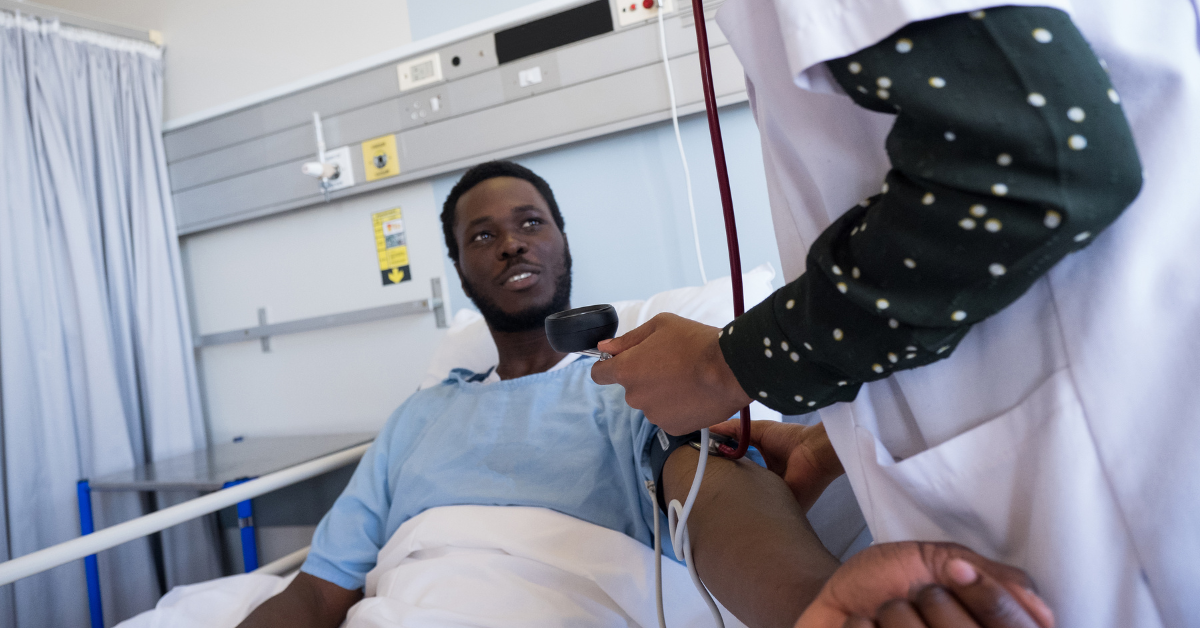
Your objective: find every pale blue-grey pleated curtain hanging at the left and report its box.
[0,12,220,628]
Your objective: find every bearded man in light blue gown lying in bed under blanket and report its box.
[231,162,1051,628]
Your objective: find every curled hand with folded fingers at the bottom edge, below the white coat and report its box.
[794,542,1054,628]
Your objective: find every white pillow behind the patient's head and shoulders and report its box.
[420,263,779,420]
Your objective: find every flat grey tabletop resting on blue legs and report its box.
[89,432,376,491]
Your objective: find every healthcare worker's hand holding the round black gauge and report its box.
[592,313,750,436]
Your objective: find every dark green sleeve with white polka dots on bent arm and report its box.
[720,7,1141,414]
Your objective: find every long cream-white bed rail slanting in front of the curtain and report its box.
[0,443,371,585]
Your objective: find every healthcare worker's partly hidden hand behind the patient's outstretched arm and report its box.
[712,419,845,513]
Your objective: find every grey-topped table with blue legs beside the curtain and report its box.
[78,432,376,628]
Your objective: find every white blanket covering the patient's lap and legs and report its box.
[120,506,743,628]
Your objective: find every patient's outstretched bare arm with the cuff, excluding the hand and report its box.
[662,447,839,628]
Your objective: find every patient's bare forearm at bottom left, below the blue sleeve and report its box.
[238,572,362,628]
